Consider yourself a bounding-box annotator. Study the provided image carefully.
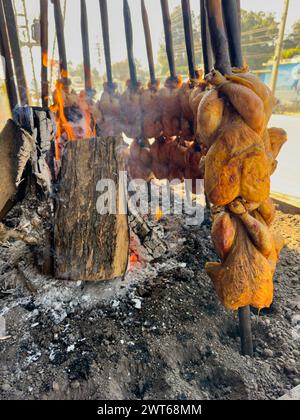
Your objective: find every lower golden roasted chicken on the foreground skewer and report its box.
[206,200,283,310]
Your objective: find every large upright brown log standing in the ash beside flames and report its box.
[54,137,129,281]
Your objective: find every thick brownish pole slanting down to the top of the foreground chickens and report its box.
[206,0,231,74]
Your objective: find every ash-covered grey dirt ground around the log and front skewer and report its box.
[0,203,300,400]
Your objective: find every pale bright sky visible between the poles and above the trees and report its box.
[10,0,300,88]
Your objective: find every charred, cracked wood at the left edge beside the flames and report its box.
[0,107,55,220]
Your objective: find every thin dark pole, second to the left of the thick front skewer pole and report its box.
[181,0,196,80]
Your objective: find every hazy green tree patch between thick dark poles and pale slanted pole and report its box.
[241,10,278,70]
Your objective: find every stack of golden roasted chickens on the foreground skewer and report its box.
[198,71,286,310]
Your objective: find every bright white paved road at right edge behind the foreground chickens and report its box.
[270,115,300,197]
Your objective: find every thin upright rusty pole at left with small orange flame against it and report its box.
[40,0,49,108]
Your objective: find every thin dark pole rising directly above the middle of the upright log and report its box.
[80,0,92,92]
